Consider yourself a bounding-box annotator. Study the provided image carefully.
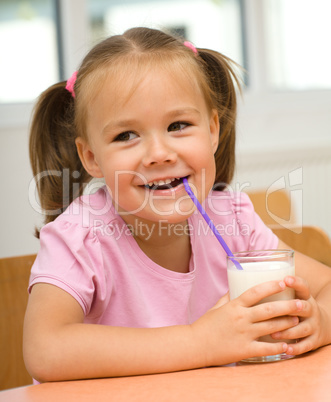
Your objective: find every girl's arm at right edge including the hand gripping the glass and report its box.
[273,242,331,354]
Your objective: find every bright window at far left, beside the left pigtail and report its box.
[0,0,59,103]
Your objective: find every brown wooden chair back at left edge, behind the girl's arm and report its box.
[0,255,36,390]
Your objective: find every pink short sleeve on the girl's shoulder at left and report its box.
[28,219,111,316]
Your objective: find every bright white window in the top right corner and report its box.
[263,0,331,90]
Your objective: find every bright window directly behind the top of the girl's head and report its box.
[88,0,244,65]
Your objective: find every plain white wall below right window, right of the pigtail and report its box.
[234,92,331,236]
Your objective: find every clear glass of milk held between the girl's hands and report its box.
[227,250,295,363]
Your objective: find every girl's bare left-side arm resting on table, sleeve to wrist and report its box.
[23,284,202,382]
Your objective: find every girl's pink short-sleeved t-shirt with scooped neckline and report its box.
[29,187,278,328]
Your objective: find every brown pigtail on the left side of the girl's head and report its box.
[29,82,91,237]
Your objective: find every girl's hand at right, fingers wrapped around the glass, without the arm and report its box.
[272,276,329,355]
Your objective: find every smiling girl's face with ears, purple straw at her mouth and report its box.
[76,69,219,223]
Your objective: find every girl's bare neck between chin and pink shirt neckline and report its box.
[129,219,191,273]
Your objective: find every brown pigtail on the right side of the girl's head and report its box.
[198,49,240,190]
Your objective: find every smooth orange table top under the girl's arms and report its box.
[0,345,331,402]
